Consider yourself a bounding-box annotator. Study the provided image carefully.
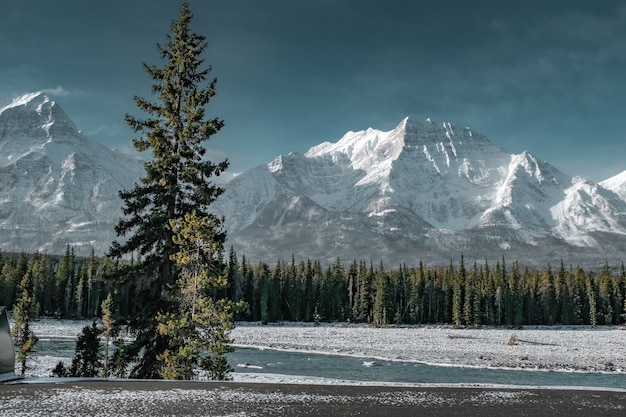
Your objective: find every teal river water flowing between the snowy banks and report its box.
[35,338,626,390]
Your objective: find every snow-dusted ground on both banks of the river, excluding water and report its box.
[0,321,626,417]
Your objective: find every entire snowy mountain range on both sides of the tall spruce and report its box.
[0,93,626,264]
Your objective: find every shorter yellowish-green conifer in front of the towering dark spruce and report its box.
[157,212,241,380]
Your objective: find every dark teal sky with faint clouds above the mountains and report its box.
[0,0,626,181]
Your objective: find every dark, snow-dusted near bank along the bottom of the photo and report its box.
[0,380,626,417]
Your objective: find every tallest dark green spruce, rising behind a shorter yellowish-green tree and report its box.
[109,2,230,378]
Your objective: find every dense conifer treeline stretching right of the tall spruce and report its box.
[227,251,626,326]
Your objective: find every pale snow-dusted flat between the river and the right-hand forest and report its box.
[232,323,626,372]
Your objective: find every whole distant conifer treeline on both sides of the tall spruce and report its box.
[0,248,626,326]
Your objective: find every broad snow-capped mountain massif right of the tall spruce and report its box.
[216,118,626,263]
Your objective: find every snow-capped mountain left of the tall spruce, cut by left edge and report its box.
[0,93,143,254]
